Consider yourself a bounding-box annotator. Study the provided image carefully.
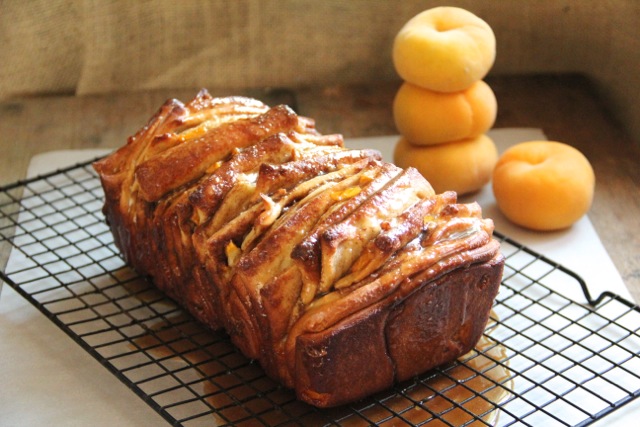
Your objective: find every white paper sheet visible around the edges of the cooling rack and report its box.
[0,129,640,426]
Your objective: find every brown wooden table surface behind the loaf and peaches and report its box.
[0,75,640,301]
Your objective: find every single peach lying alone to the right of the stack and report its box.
[493,141,595,231]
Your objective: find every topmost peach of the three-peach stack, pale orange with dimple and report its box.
[392,6,496,92]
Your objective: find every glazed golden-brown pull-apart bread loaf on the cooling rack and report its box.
[95,91,504,407]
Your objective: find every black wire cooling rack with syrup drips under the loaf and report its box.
[0,162,640,426]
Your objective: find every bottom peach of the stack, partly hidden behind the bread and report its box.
[394,134,498,194]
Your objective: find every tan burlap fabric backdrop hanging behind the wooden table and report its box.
[0,0,640,139]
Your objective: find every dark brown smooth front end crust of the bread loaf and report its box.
[295,256,503,407]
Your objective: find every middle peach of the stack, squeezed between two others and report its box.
[393,80,498,145]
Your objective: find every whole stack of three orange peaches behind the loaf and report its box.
[393,7,498,194]
